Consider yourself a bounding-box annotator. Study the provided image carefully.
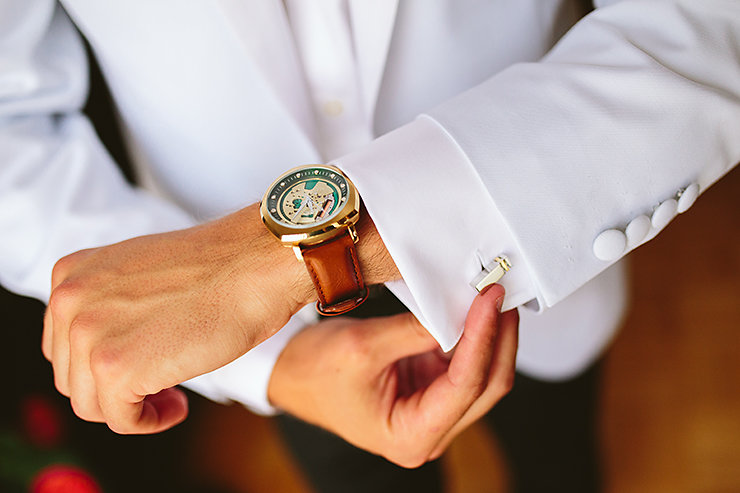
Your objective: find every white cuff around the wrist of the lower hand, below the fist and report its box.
[182,305,317,416]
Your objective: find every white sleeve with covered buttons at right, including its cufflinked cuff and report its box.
[336,0,740,349]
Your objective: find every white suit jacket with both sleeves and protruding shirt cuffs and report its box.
[0,0,740,412]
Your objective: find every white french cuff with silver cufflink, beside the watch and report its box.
[333,115,536,351]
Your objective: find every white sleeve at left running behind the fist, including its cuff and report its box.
[0,0,294,414]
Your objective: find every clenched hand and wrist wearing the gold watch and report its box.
[42,205,398,433]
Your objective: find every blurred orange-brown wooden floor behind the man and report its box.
[191,170,740,493]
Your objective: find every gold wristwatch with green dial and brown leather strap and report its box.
[260,164,367,315]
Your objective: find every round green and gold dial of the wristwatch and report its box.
[267,168,349,227]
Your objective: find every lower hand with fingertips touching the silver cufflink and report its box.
[268,285,519,467]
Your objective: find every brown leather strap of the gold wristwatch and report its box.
[301,231,367,315]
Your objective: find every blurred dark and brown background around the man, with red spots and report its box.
[0,41,740,493]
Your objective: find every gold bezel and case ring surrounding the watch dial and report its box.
[260,164,360,246]
